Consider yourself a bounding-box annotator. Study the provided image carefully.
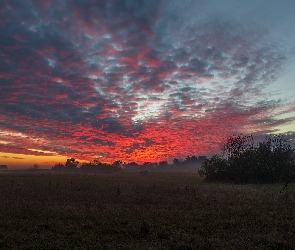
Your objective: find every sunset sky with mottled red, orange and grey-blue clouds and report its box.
[0,0,295,167]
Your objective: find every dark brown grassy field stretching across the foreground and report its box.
[0,171,295,249]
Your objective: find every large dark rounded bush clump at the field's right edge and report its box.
[199,134,295,183]
